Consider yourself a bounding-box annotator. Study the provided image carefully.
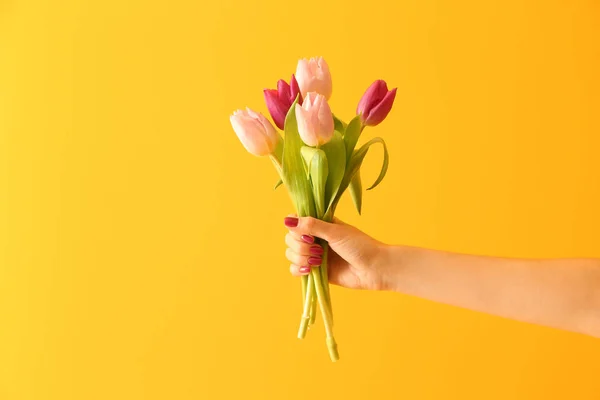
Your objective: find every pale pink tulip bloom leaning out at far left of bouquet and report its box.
[229,108,281,156]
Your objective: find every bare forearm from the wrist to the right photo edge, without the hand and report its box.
[383,247,600,337]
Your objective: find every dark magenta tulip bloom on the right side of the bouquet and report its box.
[356,80,396,126]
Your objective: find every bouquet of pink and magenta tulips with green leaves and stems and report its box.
[230,58,396,361]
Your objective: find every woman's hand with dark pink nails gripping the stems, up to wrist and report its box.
[284,216,389,290]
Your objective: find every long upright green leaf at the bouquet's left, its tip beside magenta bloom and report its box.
[282,98,315,217]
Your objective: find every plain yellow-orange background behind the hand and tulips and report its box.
[0,0,600,400]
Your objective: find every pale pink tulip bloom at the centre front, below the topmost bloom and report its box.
[295,92,334,146]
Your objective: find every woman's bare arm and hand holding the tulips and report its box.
[285,216,600,338]
